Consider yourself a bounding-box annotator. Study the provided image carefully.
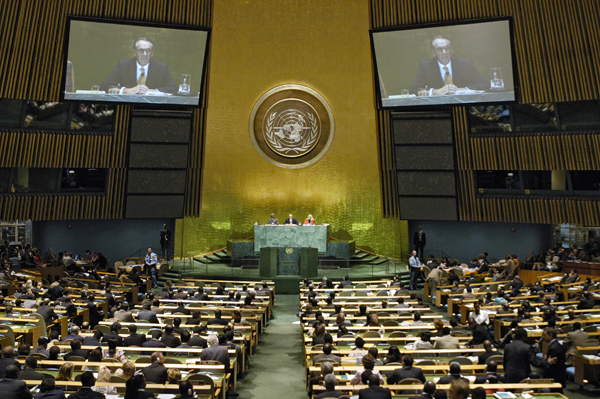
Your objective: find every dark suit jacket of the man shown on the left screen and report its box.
[100,58,177,93]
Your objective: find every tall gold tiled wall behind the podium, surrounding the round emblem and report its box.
[175,0,400,257]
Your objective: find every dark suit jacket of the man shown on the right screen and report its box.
[408,57,490,94]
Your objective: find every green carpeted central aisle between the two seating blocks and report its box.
[236,295,308,399]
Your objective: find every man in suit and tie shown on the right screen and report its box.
[409,36,489,96]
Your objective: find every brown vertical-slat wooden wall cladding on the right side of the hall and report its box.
[371,0,600,225]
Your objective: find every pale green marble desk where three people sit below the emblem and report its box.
[254,225,328,253]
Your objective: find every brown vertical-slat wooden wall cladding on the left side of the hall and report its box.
[0,0,213,220]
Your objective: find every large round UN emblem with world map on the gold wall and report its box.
[250,85,334,168]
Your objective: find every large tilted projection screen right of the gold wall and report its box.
[371,18,516,108]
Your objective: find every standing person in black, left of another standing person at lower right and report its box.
[504,328,535,383]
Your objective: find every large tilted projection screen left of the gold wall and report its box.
[62,17,209,106]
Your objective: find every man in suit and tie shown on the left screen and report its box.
[100,37,177,95]
